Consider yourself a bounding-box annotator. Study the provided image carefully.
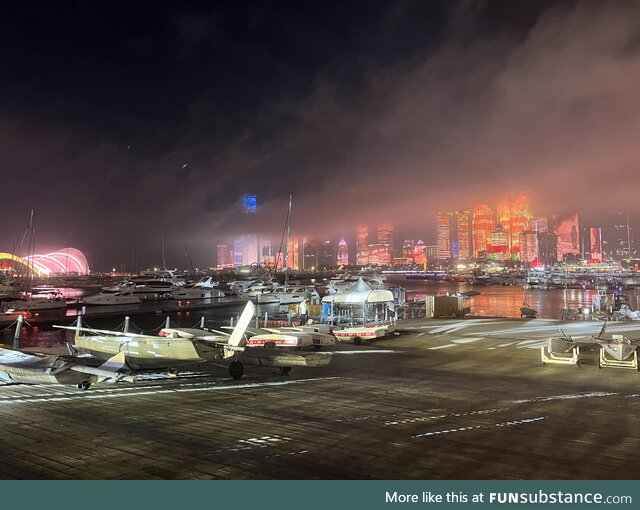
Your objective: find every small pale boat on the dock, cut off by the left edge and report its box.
[0,348,134,390]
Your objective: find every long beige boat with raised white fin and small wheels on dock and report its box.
[55,301,331,379]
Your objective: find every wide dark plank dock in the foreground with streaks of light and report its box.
[0,319,640,480]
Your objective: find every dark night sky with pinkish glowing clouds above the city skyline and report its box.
[0,0,640,270]
